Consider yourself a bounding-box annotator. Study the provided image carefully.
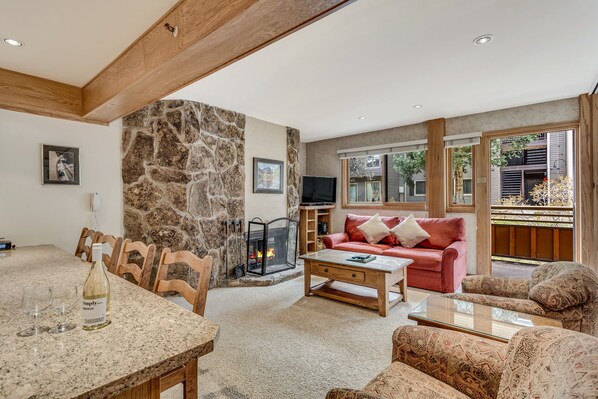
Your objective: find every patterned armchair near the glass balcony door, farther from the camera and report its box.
[445,262,598,336]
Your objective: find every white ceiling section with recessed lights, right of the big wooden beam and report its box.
[168,0,598,142]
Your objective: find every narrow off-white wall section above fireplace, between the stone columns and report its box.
[245,116,288,221]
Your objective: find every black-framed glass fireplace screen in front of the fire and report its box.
[247,218,299,276]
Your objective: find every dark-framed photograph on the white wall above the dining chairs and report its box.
[42,144,81,185]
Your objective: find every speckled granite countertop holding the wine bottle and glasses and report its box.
[0,245,219,399]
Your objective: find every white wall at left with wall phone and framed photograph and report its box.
[0,110,122,252]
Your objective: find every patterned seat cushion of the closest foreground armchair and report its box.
[363,362,469,399]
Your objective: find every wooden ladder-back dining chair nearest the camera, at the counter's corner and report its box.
[154,248,212,399]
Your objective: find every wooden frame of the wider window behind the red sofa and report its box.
[340,156,429,211]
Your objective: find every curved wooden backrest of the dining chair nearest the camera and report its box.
[154,248,212,316]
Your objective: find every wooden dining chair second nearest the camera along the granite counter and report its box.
[114,238,156,290]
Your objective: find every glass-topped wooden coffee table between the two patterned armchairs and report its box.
[407,295,562,342]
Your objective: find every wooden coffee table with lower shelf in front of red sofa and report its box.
[300,249,413,317]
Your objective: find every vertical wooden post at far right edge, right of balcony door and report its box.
[576,94,598,271]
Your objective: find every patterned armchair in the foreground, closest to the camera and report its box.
[326,326,598,399]
